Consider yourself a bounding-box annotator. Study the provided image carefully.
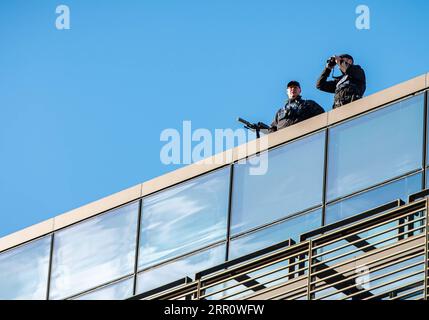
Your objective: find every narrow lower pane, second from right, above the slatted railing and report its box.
[229,210,322,260]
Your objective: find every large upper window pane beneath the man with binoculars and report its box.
[327,95,424,201]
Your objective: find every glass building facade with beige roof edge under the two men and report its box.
[0,73,429,299]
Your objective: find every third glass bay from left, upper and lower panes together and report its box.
[137,167,231,292]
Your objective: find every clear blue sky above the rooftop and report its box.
[0,0,429,237]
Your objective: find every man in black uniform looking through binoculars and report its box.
[316,54,366,109]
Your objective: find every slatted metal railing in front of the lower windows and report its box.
[133,198,429,300]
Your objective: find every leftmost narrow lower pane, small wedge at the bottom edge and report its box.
[75,278,134,300]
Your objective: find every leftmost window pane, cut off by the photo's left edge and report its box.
[0,236,51,300]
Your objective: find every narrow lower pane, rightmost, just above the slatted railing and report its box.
[326,173,422,224]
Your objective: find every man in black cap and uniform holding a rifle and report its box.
[270,81,325,132]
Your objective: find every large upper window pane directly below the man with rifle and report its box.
[231,132,325,235]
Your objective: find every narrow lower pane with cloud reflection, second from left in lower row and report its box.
[137,245,225,293]
